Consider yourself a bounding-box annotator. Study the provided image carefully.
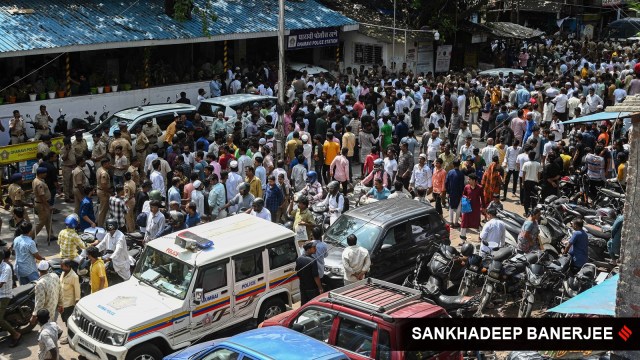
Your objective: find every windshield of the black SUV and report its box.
[325,214,382,252]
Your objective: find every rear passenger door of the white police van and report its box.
[232,248,267,320]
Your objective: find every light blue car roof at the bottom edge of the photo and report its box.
[219,326,346,359]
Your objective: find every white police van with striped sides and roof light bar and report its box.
[68,214,300,360]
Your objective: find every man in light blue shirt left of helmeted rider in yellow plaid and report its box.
[13,222,44,285]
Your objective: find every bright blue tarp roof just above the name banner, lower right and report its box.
[547,274,620,316]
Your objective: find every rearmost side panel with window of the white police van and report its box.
[267,238,299,295]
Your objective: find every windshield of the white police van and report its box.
[133,246,193,300]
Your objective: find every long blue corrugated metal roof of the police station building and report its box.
[0,0,356,53]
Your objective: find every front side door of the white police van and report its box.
[189,259,231,338]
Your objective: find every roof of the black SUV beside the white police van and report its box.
[346,199,437,227]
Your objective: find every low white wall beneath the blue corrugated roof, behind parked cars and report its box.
[0,82,209,146]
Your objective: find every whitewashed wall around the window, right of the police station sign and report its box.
[343,31,415,74]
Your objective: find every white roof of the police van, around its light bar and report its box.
[147,214,295,265]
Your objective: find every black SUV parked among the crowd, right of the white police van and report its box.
[322,199,450,289]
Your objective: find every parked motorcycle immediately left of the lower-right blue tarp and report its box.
[518,253,572,318]
